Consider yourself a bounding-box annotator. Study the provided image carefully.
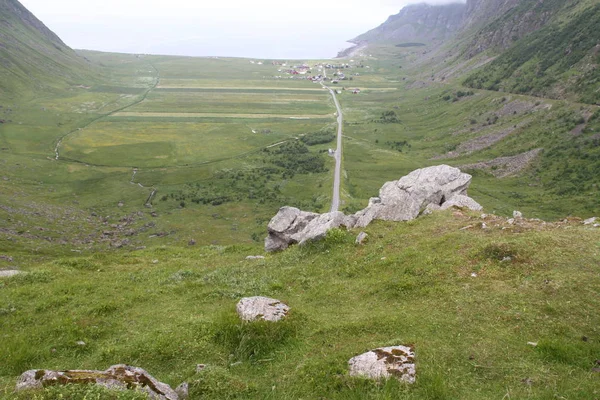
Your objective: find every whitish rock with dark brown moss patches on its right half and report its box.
[348,346,416,383]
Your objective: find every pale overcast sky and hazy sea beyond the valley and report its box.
[20,0,460,59]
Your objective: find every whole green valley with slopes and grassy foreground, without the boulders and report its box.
[0,0,600,400]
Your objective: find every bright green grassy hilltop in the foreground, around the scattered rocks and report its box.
[0,211,600,400]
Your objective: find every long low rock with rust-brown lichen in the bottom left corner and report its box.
[15,364,179,400]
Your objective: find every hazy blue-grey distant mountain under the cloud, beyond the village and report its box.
[353,4,466,44]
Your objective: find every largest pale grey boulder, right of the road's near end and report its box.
[353,165,474,228]
